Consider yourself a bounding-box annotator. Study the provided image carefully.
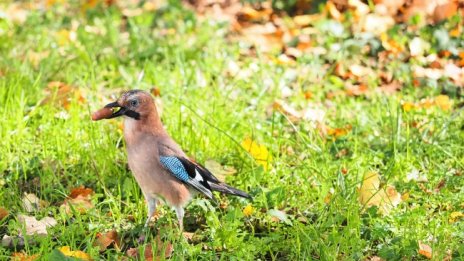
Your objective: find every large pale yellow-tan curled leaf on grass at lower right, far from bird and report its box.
[359,172,401,215]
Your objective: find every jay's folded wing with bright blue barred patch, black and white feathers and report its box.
[160,156,217,199]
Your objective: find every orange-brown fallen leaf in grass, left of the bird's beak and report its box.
[40,81,85,109]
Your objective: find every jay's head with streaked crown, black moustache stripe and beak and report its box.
[105,90,157,120]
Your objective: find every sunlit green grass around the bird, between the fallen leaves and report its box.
[0,2,464,260]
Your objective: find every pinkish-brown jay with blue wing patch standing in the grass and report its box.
[95,90,251,231]
